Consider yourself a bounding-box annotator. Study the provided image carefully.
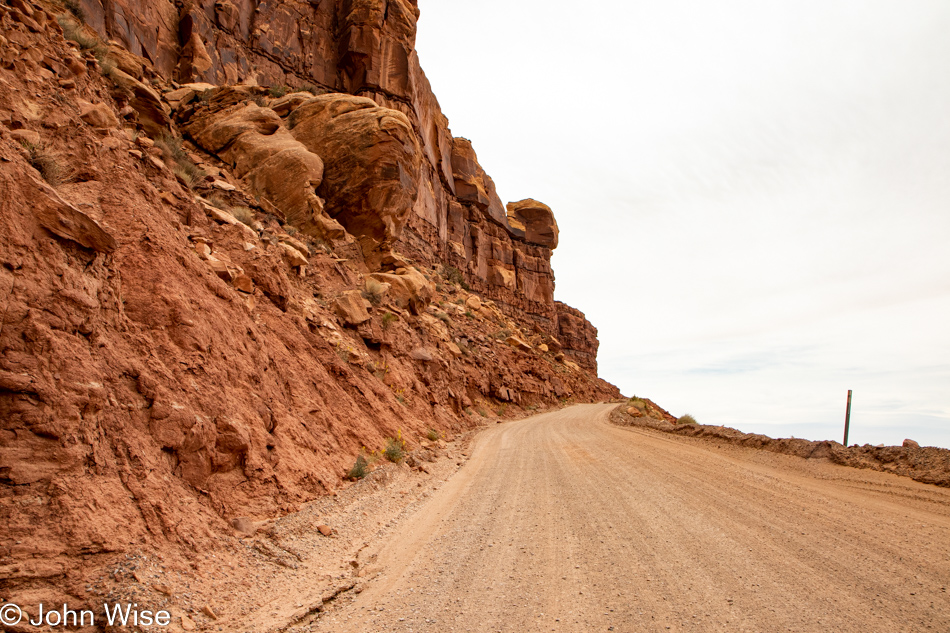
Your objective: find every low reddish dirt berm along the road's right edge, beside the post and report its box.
[611,405,950,487]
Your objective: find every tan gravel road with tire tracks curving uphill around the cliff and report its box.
[315,405,950,633]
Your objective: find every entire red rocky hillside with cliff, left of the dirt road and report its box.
[0,0,619,604]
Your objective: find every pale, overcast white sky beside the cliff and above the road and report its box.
[416,0,950,448]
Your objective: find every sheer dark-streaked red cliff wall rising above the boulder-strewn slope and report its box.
[82,0,589,336]
